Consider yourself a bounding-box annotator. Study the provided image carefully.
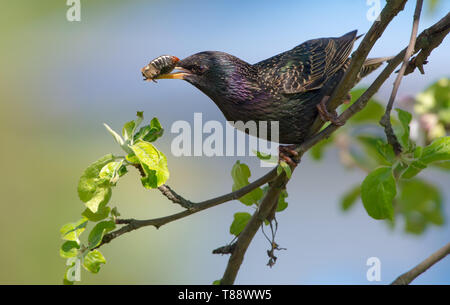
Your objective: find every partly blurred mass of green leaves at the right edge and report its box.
[310,78,450,234]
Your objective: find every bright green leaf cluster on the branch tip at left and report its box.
[60,112,169,284]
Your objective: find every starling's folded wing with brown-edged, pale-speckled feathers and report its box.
[254,31,356,94]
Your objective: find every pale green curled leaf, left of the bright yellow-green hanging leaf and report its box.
[78,154,114,202]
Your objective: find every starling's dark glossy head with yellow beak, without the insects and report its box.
[156,51,256,102]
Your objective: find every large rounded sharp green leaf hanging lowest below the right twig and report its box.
[361,166,397,220]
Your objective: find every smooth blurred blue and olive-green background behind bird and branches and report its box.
[0,0,450,284]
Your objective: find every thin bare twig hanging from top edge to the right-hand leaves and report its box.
[380,0,423,155]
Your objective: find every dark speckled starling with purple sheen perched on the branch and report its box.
[142,31,390,163]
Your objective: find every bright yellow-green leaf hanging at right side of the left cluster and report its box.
[130,141,169,188]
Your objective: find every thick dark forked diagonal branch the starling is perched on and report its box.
[220,5,450,285]
